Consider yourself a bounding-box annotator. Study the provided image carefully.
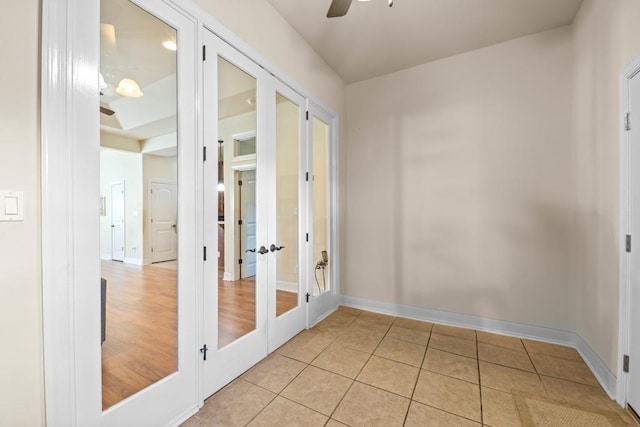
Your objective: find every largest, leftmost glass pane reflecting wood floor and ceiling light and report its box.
[96,0,178,409]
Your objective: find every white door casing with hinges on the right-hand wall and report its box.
[616,56,640,407]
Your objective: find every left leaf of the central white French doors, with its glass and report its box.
[202,32,268,396]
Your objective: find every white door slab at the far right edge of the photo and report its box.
[627,68,640,413]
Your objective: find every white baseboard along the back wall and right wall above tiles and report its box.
[341,296,617,399]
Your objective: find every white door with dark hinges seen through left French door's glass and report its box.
[237,169,258,279]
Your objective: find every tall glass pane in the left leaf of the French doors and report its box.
[218,57,257,348]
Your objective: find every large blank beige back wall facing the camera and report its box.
[342,27,575,330]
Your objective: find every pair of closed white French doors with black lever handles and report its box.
[202,33,309,396]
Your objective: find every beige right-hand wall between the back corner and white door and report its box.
[572,0,640,372]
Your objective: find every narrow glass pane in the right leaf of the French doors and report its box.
[274,93,300,316]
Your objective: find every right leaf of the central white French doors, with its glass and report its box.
[269,80,307,351]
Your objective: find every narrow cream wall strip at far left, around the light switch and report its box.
[0,0,44,427]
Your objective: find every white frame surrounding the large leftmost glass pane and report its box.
[41,0,202,427]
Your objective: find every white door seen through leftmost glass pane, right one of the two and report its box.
[149,182,178,262]
